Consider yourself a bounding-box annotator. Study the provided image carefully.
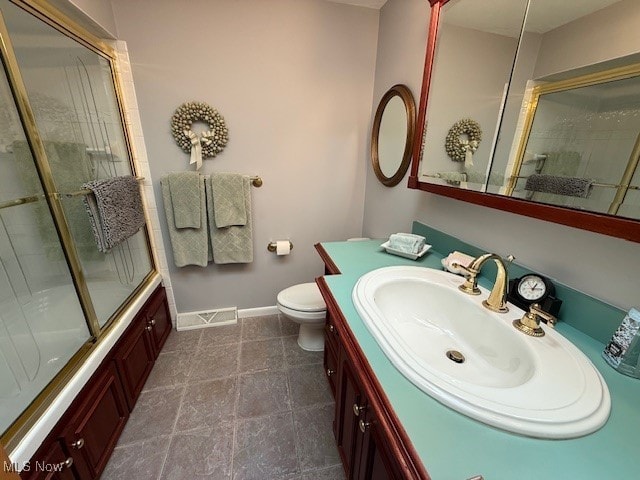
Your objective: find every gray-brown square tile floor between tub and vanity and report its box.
[102,315,344,480]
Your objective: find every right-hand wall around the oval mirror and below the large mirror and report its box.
[363,0,640,309]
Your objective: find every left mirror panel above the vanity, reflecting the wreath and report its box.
[421,0,527,190]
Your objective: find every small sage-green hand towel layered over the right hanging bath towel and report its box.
[211,173,247,228]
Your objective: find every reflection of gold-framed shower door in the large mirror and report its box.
[494,64,640,218]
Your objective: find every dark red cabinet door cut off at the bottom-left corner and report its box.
[20,441,83,480]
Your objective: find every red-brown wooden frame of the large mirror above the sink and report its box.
[408,0,640,242]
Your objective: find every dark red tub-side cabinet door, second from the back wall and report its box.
[113,312,155,411]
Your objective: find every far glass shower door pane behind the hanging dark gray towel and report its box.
[0,0,153,327]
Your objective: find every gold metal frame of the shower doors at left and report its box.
[0,0,157,451]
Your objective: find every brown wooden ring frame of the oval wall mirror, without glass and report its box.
[371,84,416,187]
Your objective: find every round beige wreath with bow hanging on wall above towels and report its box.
[171,102,229,169]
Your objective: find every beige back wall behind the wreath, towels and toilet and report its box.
[112,0,378,312]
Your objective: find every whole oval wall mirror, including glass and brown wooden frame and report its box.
[371,85,416,187]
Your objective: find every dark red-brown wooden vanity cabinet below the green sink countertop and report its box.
[317,278,429,480]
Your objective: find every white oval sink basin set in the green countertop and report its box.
[353,267,611,438]
